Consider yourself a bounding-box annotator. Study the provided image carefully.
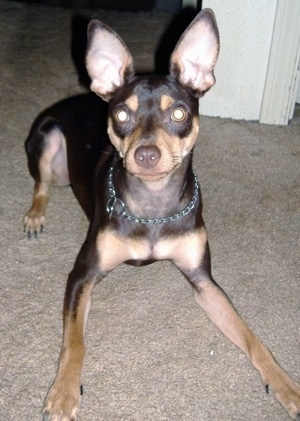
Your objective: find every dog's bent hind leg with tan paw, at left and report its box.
[24,118,70,237]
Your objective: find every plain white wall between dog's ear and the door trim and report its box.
[200,0,277,120]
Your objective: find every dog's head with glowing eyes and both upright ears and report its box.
[86,9,219,180]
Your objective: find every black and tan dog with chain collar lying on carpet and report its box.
[24,9,300,421]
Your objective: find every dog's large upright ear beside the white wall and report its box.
[170,9,219,97]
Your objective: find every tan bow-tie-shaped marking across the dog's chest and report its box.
[97,228,207,272]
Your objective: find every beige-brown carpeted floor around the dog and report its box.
[0,0,300,421]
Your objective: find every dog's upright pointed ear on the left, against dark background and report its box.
[86,20,134,101]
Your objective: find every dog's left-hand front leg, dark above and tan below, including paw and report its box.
[43,254,104,421]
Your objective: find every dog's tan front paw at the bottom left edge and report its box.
[43,384,80,421]
